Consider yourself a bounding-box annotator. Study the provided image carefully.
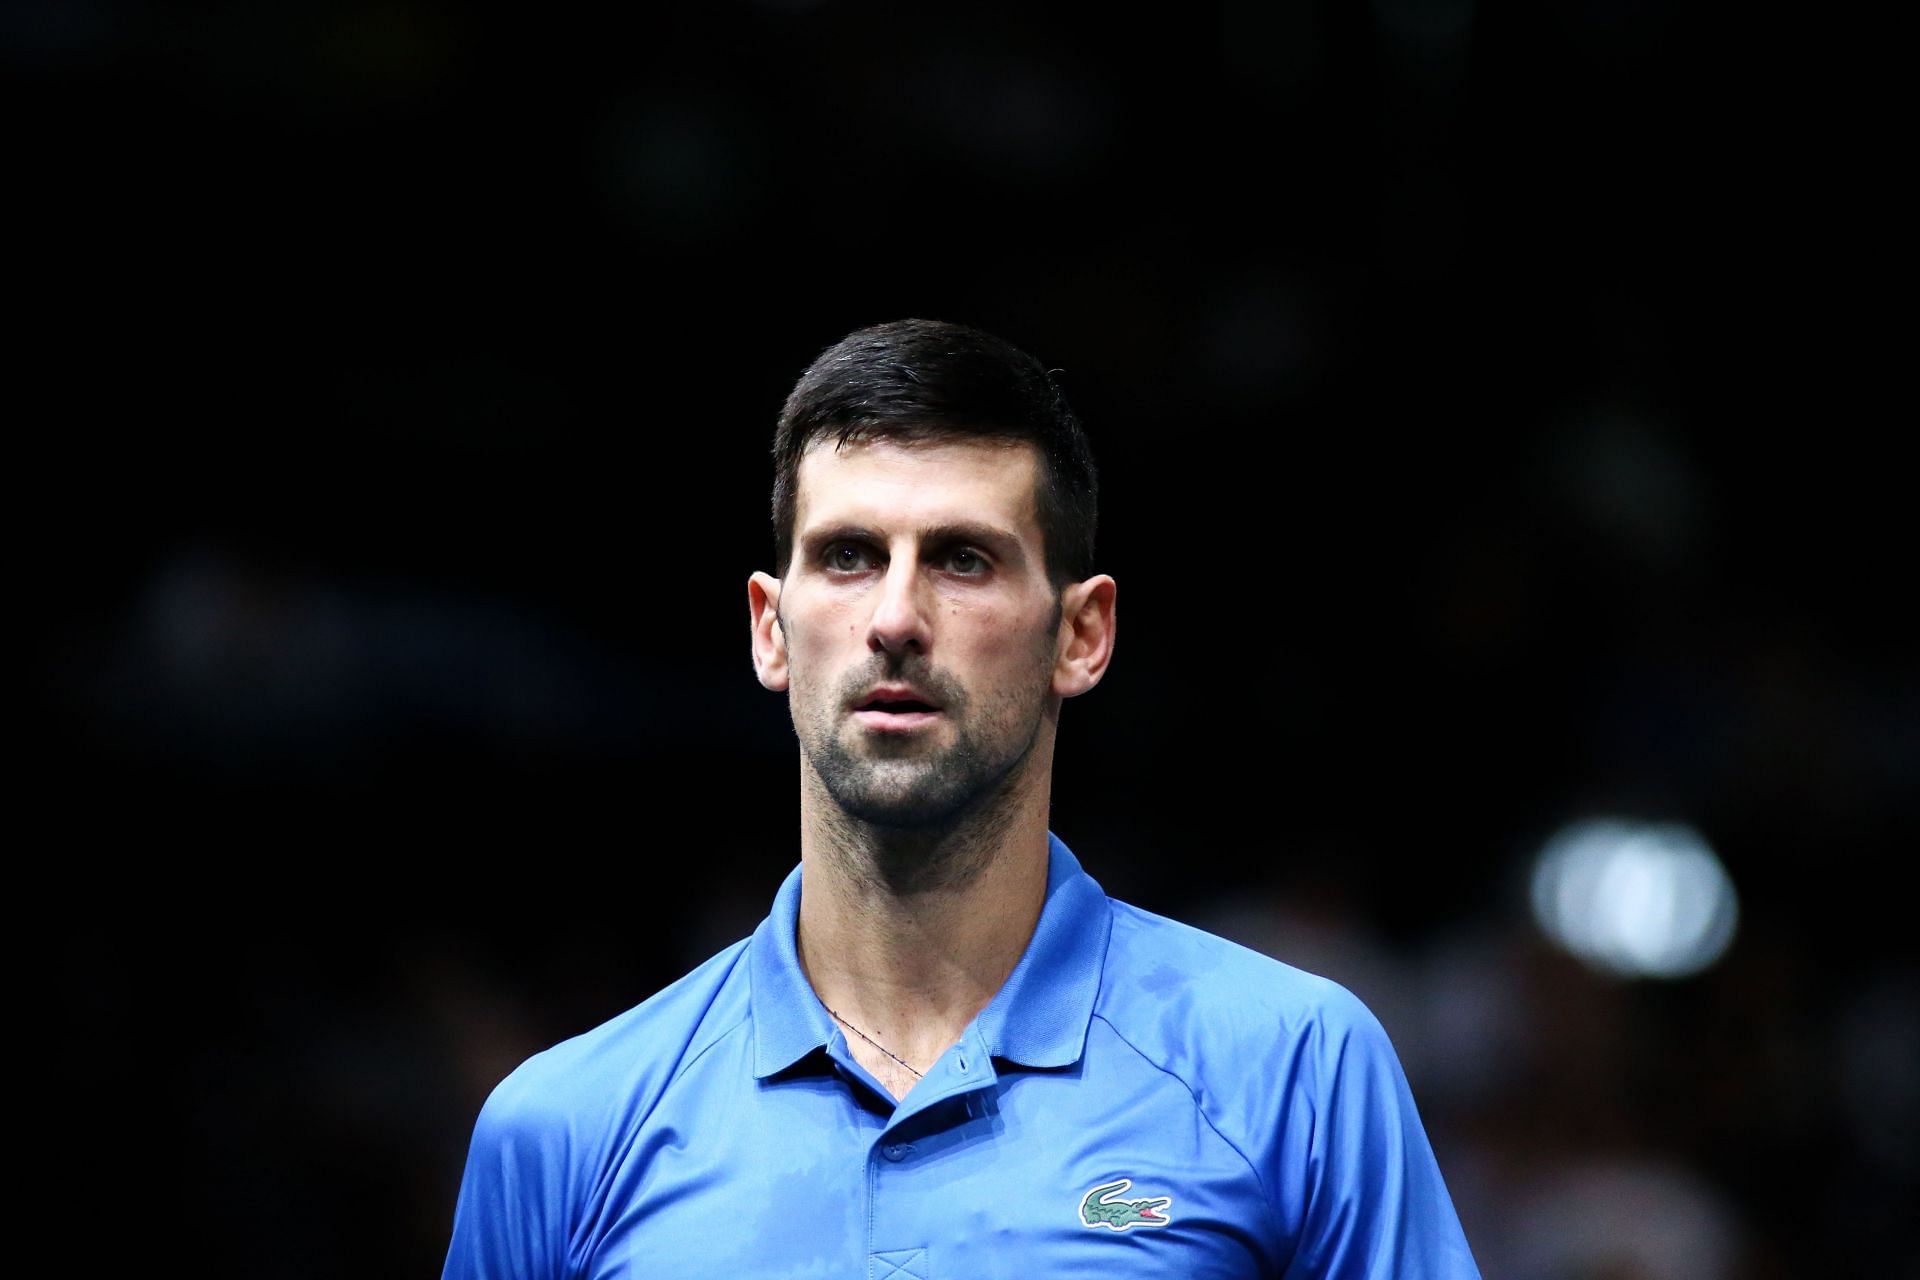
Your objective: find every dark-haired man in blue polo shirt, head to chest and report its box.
[445,320,1476,1280]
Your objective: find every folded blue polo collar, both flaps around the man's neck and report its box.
[749,831,1114,1080]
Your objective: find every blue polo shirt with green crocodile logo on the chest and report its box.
[444,835,1478,1280]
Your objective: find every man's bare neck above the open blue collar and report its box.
[797,752,1050,1092]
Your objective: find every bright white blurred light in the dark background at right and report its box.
[1532,818,1740,979]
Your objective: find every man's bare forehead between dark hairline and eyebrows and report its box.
[795,439,1041,545]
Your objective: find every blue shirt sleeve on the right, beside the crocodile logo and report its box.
[1286,992,1480,1280]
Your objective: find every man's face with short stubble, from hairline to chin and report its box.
[762,439,1060,827]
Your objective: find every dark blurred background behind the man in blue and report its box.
[22,0,1920,1280]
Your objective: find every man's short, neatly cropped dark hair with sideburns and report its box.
[774,320,1100,589]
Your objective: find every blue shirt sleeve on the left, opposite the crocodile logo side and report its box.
[442,1077,572,1280]
